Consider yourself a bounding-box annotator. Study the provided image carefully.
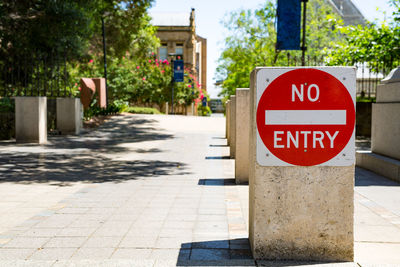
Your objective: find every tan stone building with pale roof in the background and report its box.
[152,8,207,90]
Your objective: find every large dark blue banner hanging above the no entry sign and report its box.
[276,0,301,50]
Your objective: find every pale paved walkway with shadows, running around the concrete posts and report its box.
[0,115,400,266]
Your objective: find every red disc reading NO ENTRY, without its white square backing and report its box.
[257,68,355,166]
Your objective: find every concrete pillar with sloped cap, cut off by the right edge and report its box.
[371,68,400,160]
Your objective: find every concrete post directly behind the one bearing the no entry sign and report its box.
[235,88,250,184]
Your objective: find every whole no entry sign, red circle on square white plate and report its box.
[256,67,355,166]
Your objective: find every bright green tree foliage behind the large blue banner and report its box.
[216,0,341,97]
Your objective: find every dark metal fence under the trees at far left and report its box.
[0,53,71,97]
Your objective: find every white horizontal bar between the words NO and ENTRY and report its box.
[265,110,346,125]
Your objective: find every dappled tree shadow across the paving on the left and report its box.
[0,116,188,186]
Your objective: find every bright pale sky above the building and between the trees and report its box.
[149,0,392,98]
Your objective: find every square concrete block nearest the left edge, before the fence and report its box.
[15,96,47,144]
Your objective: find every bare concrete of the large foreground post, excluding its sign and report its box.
[249,69,354,261]
